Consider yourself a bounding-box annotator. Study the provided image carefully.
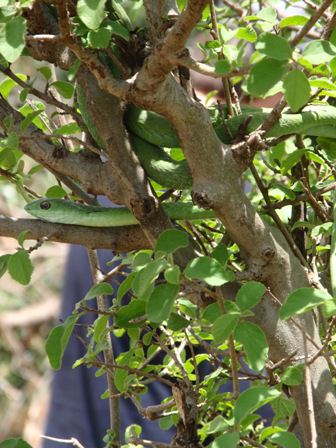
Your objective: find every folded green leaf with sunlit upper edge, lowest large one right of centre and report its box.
[233,386,281,423]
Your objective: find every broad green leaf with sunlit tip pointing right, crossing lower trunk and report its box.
[280,288,332,320]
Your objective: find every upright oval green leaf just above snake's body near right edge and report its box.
[284,70,310,112]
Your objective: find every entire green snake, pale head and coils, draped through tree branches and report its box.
[25,102,336,227]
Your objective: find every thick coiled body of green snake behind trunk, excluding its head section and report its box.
[125,106,336,190]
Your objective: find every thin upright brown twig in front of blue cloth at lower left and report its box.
[87,249,120,446]
